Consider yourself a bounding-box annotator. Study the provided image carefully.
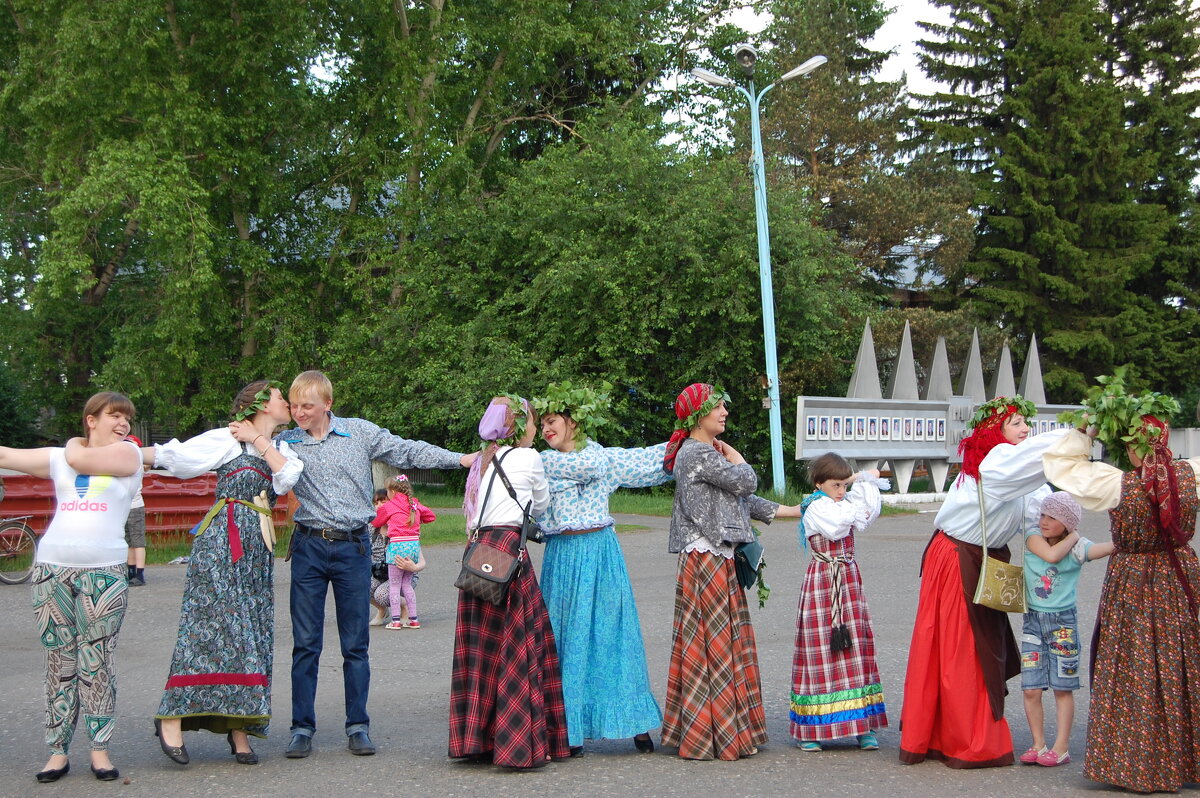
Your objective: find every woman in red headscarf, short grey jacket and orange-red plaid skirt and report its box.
[662,383,800,760]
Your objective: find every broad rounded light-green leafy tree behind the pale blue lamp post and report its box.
[319,120,862,480]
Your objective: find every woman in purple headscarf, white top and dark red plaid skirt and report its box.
[450,396,570,769]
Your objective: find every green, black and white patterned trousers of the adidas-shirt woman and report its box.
[34,563,128,754]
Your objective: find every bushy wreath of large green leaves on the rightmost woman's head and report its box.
[1058,366,1180,469]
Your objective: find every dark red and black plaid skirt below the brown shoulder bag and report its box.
[450,527,570,768]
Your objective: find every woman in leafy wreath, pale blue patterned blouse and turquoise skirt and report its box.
[534,385,671,755]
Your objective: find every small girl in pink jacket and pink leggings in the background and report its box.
[371,474,437,629]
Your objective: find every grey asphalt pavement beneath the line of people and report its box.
[0,505,1109,798]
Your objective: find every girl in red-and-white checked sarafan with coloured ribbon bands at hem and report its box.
[791,452,889,751]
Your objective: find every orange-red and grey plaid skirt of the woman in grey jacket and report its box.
[662,552,767,760]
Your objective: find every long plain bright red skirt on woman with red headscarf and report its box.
[900,533,1013,768]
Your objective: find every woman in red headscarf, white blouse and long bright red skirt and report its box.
[900,396,1066,768]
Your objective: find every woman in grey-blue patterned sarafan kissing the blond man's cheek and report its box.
[146,380,304,764]
